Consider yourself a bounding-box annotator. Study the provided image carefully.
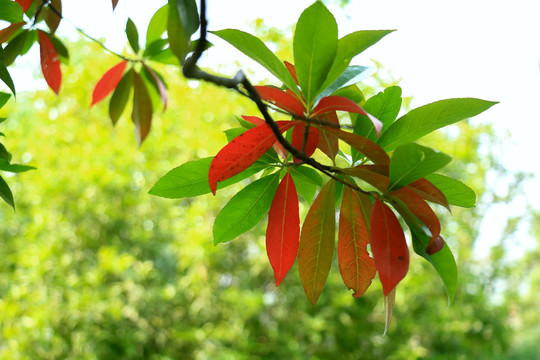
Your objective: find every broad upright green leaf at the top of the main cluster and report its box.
[293,1,336,107]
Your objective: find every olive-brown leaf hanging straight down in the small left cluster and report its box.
[131,71,154,146]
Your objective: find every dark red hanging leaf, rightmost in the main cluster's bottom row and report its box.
[370,198,409,296]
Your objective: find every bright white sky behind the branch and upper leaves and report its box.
[4,0,540,256]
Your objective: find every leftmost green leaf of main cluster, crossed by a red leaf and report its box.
[149,157,266,199]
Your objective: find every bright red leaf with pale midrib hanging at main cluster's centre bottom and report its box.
[266,171,300,286]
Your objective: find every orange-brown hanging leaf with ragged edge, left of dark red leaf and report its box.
[337,187,377,297]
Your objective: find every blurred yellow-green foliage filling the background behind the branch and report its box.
[0,38,539,360]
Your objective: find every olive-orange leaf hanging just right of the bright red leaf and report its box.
[298,180,336,306]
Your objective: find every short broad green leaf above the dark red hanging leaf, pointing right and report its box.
[388,143,452,191]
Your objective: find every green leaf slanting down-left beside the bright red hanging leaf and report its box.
[214,172,279,245]
